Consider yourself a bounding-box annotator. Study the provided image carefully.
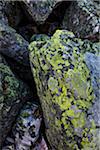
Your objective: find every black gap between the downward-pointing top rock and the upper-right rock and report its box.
[38,1,72,35]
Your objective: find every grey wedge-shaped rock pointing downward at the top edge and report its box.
[21,0,62,24]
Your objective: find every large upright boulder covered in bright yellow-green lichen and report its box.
[29,30,100,150]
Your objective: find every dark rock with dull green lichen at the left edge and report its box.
[0,55,32,149]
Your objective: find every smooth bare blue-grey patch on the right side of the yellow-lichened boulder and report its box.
[85,52,100,128]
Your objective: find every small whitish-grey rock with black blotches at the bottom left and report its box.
[3,101,42,150]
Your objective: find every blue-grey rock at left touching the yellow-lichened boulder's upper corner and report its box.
[0,22,29,66]
